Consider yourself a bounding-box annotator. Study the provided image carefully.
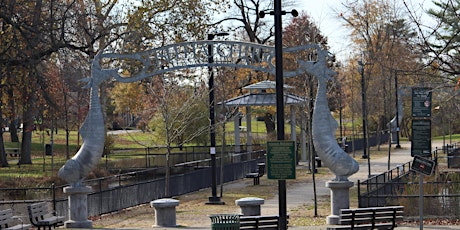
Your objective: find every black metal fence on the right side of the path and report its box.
[358,143,460,219]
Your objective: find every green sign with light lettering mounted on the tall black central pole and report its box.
[267,141,296,180]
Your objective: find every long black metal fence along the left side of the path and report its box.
[0,151,265,222]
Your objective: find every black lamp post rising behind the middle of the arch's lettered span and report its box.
[206,33,228,204]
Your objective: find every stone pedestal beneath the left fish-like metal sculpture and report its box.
[64,185,93,228]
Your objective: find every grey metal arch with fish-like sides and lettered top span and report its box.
[58,41,357,186]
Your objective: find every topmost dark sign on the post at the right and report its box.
[412,88,432,117]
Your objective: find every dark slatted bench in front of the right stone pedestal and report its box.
[328,206,404,230]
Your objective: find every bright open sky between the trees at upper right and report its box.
[296,0,433,60]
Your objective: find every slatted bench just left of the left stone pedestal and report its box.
[27,202,65,229]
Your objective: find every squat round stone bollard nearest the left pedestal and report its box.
[150,198,179,227]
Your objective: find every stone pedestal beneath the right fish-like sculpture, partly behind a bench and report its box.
[326,181,353,225]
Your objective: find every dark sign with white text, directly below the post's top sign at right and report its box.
[411,119,431,156]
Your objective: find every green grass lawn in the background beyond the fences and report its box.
[0,126,460,186]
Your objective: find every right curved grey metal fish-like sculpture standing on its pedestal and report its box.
[304,50,359,181]
